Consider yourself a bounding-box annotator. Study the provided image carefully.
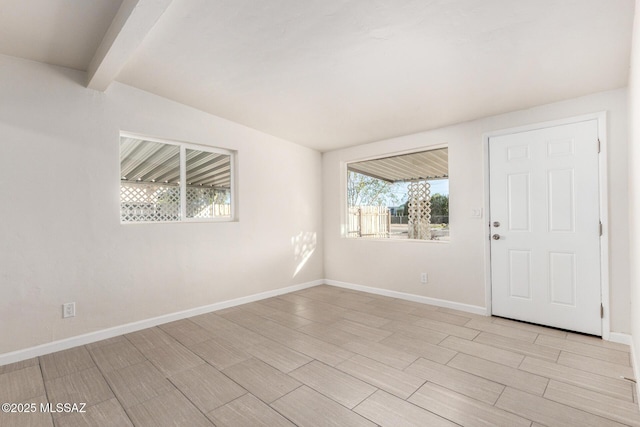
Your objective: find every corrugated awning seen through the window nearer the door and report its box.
[347,148,449,182]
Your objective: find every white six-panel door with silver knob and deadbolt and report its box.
[489,120,602,335]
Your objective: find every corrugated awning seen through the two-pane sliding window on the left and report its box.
[120,137,231,188]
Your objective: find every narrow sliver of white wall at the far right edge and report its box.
[629,0,640,392]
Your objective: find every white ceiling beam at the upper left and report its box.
[87,0,172,91]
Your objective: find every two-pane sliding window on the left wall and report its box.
[120,134,234,223]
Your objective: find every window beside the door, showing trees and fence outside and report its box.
[346,148,449,241]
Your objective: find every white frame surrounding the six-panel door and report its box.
[482,111,611,341]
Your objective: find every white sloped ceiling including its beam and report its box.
[0,0,634,151]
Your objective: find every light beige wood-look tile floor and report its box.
[0,286,640,427]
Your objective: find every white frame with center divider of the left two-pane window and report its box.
[118,131,238,225]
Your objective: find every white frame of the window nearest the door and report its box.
[340,143,451,244]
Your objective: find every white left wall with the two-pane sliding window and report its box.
[0,56,324,355]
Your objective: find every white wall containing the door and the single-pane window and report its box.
[323,89,630,333]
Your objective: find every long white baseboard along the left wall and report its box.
[0,280,325,366]
